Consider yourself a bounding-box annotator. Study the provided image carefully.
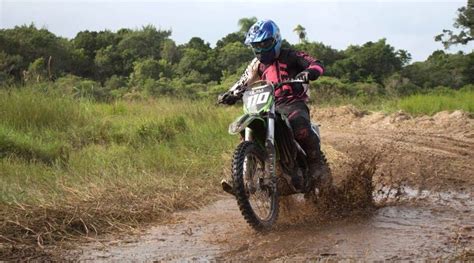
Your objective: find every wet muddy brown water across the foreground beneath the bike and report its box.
[74,188,474,261]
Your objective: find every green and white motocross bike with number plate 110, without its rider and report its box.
[218,80,332,231]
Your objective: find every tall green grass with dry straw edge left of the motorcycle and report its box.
[0,89,240,258]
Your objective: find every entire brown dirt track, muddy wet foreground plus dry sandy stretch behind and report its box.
[68,107,474,261]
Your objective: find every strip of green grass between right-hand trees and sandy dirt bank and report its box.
[311,77,474,115]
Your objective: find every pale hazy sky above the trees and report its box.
[0,0,474,62]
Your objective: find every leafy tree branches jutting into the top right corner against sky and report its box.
[435,0,474,49]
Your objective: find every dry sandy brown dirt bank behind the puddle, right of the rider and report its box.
[312,106,474,191]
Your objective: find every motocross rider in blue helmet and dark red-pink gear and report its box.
[219,20,324,191]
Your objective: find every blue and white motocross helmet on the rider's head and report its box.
[245,20,282,64]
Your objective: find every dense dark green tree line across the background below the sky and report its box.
[0,0,474,100]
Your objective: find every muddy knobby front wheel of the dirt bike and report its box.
[232,141,278,231]
